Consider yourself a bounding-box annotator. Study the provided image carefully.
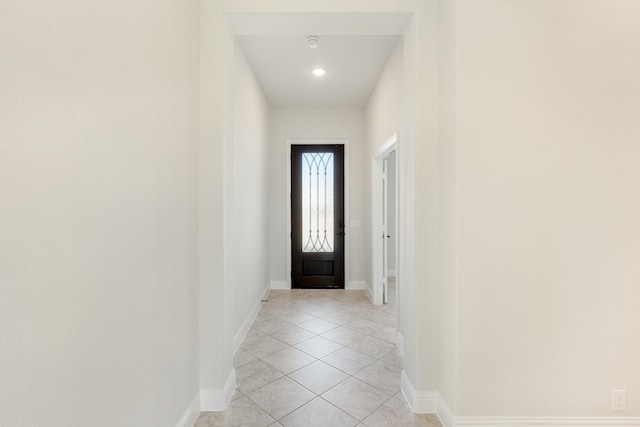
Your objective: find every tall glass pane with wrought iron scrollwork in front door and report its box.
[302,153,334,252]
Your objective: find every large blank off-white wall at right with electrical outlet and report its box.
[455,0,640,417]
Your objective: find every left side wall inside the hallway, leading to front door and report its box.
[232,41,270,338]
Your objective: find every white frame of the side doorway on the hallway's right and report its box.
[370,133,400,305]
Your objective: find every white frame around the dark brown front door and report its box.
[285,139,352,289]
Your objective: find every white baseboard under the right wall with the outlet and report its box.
[451,417,640,427]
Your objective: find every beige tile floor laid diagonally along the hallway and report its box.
[195,282,442,427]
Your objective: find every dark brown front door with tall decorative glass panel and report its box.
[291,145,345,289]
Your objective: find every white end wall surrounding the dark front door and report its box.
[269,108,370,290]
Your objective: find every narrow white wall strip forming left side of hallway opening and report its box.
[198,0,235,404]
